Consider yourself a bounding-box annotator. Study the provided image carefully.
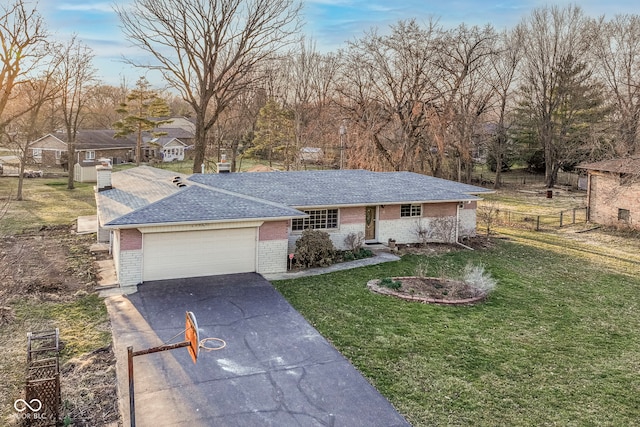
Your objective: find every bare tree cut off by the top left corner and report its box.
[0,0,47,131]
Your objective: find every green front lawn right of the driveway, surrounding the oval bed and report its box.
[274,241,640,426]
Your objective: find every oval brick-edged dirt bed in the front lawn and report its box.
[367,277,486,304]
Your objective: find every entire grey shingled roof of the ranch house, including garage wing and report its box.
[97,166,491,226]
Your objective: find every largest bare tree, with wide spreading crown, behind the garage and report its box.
[116,0,301,172]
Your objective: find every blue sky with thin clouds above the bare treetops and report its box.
[38,0,640,85]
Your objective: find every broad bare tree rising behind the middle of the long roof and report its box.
[337,20,441,170]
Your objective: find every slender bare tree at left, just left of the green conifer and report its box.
[56,36,96,190]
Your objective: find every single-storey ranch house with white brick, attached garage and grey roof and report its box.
[96,165,491,286]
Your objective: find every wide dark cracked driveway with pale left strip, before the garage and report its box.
[106,273,409,427]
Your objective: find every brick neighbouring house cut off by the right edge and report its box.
[579,156,640,229]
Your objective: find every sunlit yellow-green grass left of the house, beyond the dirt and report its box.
[0,178,96,236]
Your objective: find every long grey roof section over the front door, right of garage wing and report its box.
[189,170,491,207]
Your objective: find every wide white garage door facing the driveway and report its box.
[142,228,256,281]
